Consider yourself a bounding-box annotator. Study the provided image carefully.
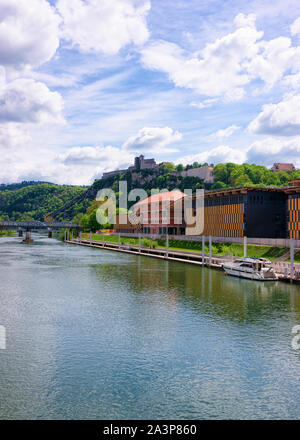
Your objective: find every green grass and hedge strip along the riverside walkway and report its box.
[82,233,290,262]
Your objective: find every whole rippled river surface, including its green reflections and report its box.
[0,235,300,419]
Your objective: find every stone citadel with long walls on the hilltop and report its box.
[102,154,215,183]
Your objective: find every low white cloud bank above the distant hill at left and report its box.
[0,143,134,185]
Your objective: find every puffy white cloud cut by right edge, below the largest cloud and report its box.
[248,94,300,136]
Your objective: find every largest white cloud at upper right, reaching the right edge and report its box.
[141,14,300,99]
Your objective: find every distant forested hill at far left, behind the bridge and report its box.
[0,183,89,221]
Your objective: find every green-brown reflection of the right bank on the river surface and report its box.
[94,257,300,322]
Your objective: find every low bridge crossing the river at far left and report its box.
[0,220,81,243]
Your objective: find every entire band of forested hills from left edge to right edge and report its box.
[0,163,300,221]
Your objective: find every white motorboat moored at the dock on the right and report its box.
[223,257,278,281]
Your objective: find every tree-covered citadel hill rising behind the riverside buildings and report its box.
[53,162,300,221]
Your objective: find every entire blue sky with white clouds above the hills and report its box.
[0,0,300,184]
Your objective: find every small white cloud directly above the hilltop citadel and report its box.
[123,127,182,154]
